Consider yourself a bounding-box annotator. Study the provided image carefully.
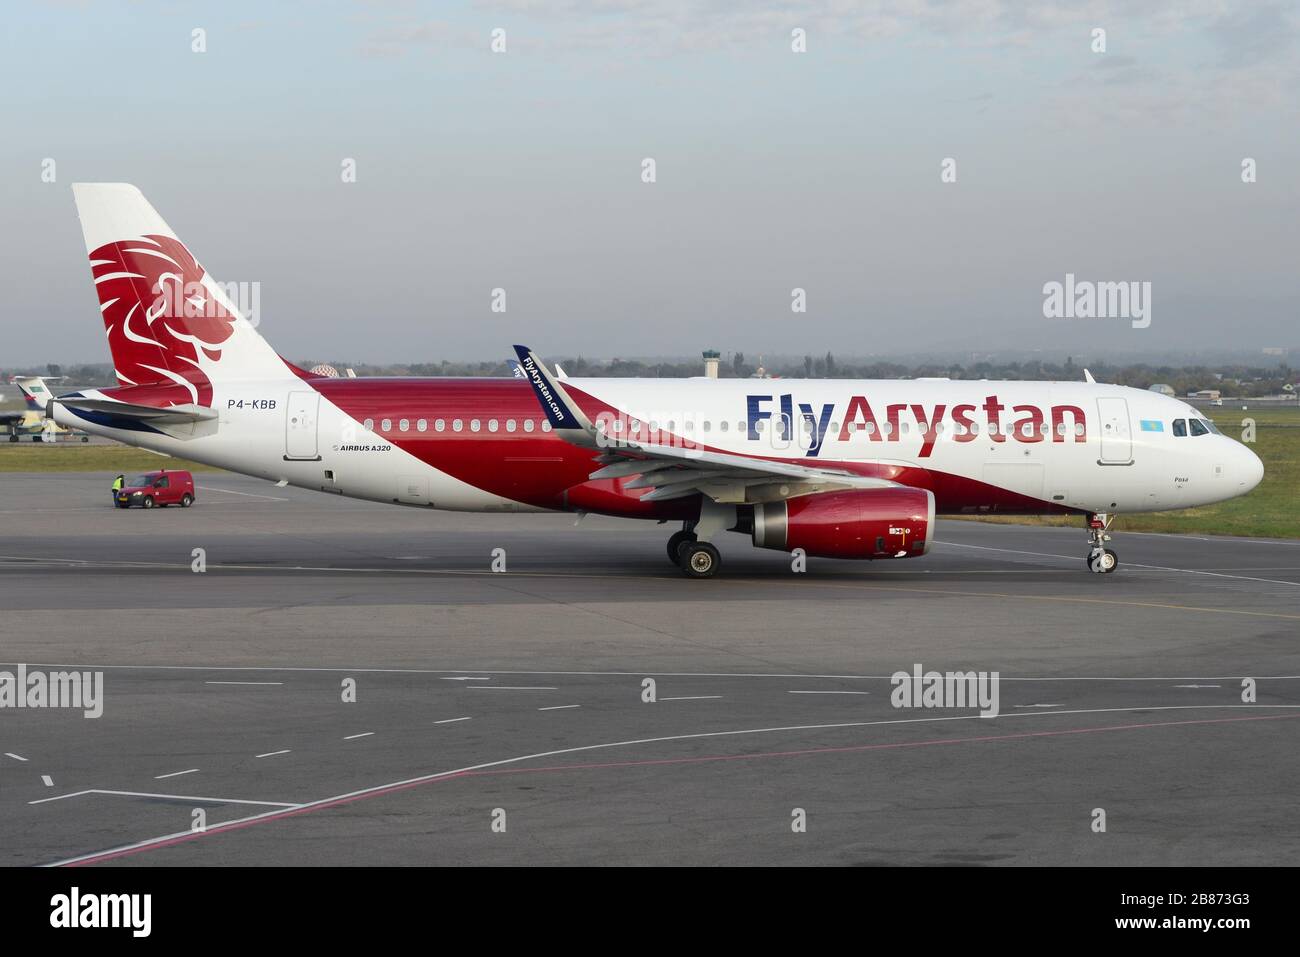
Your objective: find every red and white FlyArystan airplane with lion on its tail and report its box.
[51,183,1264,577]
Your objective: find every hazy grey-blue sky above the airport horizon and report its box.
[0,0,1300,369]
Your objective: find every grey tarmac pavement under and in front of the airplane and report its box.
[0,473,1300,865]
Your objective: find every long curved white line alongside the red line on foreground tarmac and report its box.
[44,705,1300,867]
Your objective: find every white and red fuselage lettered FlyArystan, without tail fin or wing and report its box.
[55,377,1262,512]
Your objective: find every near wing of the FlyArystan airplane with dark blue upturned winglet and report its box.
[515,346,898,503]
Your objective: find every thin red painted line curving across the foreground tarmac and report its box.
[66,714,1300,867]
